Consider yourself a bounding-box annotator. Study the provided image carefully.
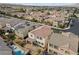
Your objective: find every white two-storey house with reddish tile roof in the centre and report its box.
[26,25,51,47]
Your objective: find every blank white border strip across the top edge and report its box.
[0,0,79,3]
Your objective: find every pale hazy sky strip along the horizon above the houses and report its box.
[0,3,79,7]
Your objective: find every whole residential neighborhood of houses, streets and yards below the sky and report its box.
[0,3,79,55]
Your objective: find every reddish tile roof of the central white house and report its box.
[31,25,51,37]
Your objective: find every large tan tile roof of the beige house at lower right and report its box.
[49,33,79,52]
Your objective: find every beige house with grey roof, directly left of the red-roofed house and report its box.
[15,21,39,38]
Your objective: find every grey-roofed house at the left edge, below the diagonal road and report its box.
[0,17,25,30]
